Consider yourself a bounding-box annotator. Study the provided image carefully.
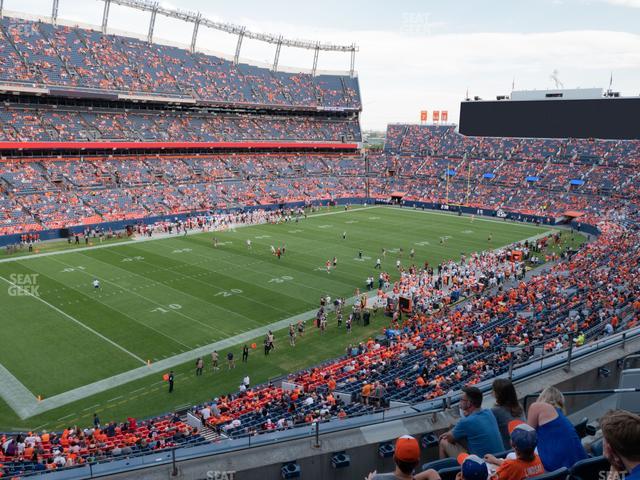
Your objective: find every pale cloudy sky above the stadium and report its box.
[4,0,640,129]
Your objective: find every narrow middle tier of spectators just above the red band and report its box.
[0,105,360,142]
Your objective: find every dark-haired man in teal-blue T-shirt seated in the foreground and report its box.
[440,387,504,458]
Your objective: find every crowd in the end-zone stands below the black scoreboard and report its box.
[369,124,640,217]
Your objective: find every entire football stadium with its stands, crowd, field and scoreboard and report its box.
[0,0,640,480]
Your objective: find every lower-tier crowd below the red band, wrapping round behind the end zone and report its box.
[0,136,640,233]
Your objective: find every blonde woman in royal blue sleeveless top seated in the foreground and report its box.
[527,387,587,472]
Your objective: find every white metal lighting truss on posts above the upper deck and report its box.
[96,0,358,76]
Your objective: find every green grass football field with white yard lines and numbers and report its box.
[0,207,576,431]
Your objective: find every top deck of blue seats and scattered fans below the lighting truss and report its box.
[0,17,361,109]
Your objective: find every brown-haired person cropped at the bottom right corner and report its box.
[600,410,640,480]
